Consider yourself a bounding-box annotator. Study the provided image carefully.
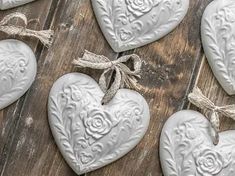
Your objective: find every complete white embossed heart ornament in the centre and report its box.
[48,73,150,174]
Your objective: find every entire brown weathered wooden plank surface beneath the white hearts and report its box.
[0,0,235,176]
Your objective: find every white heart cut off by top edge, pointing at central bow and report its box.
[92,0,189,52]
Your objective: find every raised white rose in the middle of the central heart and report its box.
[84,109,114,139]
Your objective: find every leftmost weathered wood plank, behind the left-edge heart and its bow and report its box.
[0,0,56,171]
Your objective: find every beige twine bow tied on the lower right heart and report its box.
[188,87,235,145]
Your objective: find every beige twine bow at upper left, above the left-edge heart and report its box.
[0,12,54,47]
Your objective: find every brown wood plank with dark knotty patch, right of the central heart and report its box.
[86,0,211,176]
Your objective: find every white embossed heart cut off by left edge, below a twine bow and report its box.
[0,39,37,110]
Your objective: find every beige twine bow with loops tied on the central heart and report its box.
[73,51,142,104]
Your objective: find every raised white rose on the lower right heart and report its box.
[196,149,224,176]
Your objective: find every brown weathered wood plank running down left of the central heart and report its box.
[2,0,117,176]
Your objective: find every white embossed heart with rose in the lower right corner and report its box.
[160,110,235,176]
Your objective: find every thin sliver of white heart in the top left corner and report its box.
[0,0,34,10]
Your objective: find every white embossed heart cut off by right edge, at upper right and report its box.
[201,0,235,95]
